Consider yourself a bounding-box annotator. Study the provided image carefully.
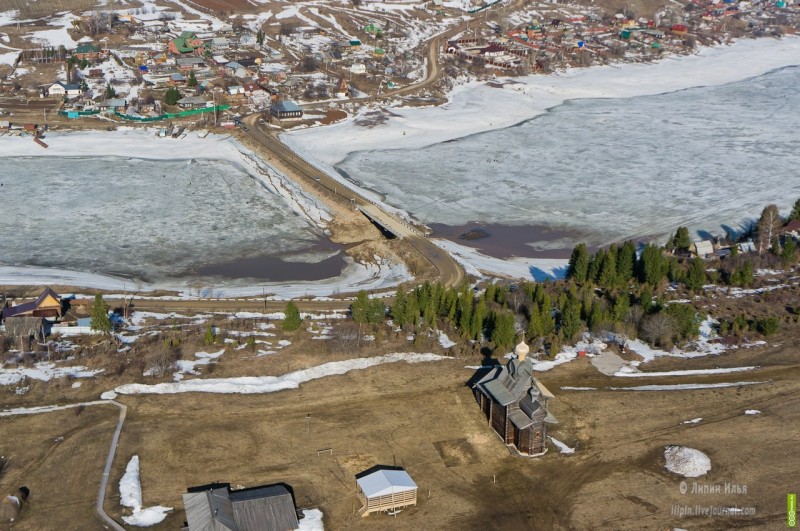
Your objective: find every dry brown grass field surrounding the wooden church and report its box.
[0,334,800,529]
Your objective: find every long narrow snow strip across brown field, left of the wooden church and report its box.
[103,353,450,397]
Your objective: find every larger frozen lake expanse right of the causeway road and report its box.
[337,67,800,254]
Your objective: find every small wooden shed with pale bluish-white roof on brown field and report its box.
[356,469,417,516]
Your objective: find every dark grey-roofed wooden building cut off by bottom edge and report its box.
[183,483,299,531]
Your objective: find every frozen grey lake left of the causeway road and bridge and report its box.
[0,156,344,281]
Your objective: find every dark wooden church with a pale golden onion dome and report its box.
[472,343,558,457]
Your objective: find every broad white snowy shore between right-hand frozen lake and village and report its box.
[281,37,800,165]
